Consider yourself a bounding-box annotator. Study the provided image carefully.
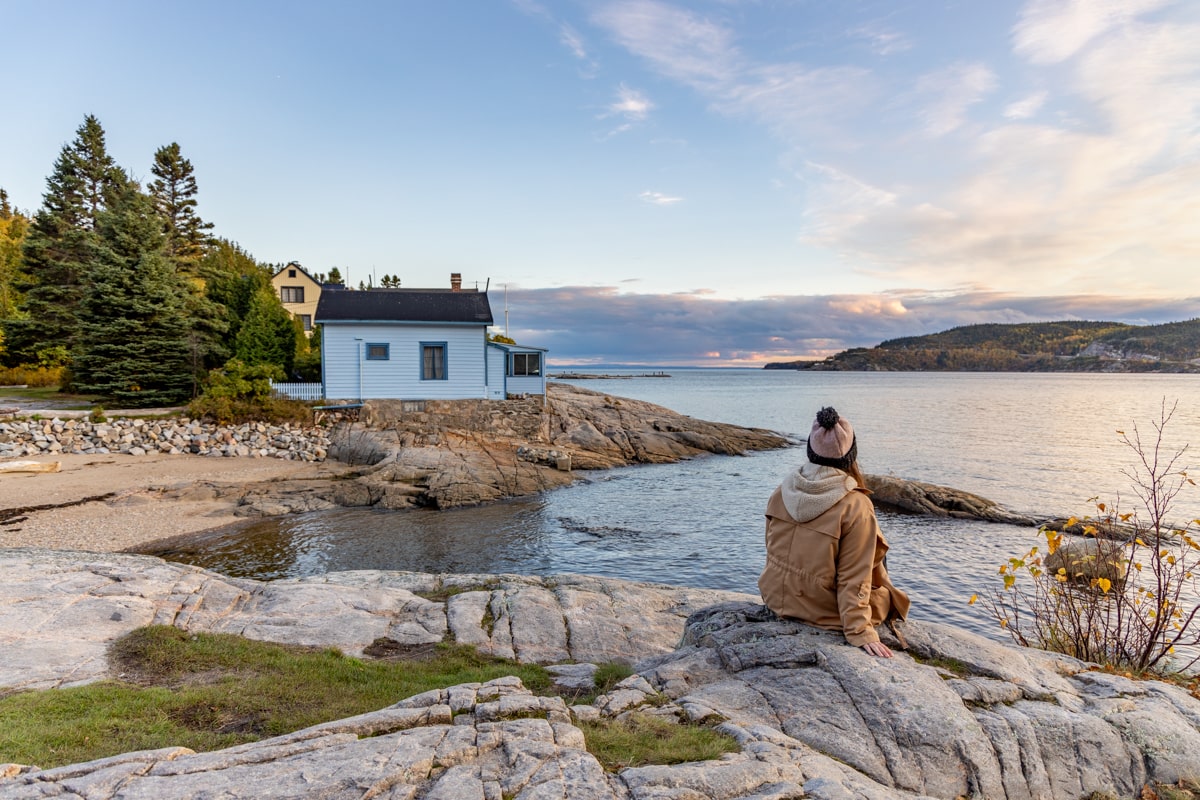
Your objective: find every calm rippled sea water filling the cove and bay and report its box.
[142,369,1200,636]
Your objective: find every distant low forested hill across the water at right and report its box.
[764,319,1200,373]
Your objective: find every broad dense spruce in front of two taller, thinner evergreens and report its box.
[72,184,192,407]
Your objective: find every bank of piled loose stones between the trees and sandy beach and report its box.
[0,417,329,461]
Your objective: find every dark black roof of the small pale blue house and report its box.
[314,289,492,325]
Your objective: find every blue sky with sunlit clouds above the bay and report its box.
[0,0,1200,366]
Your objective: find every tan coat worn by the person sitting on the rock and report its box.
[758,489,908,646]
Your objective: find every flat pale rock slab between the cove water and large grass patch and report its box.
[0,548,746,691]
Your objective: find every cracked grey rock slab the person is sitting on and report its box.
[642,603,1200,800]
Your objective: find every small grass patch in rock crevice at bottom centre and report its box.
[580,714,740,772]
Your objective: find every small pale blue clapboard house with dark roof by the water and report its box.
[316,273,546,401]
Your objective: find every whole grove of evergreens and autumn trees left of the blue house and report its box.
[0,115,340,407]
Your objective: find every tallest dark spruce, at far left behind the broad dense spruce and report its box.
[4,115,128,366]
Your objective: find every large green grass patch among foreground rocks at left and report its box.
[0,626,551,769]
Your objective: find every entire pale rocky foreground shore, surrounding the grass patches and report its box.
[0,549,1200,800]
